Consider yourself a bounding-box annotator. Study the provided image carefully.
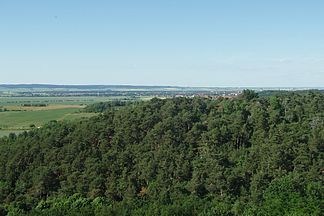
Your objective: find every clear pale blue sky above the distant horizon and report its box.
[0,0,324,87]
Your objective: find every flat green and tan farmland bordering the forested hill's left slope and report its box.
[0,96,152,137]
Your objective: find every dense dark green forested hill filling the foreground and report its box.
[0,91,324,215]
